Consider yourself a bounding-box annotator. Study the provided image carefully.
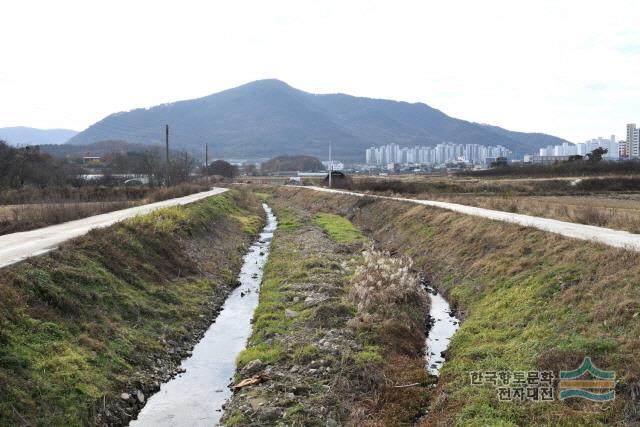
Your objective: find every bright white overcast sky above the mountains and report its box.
[0,0,640,142]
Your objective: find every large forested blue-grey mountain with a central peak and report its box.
[69,80,566,161]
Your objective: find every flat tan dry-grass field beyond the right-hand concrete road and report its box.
[352,176,640,233]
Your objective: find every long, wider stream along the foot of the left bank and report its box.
[129,204,277,427]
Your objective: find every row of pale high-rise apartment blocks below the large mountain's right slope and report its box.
[366,143,512,165]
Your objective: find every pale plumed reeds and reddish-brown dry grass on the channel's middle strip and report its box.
[342,249,429,427]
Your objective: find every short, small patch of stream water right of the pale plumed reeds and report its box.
[426,287,460,375]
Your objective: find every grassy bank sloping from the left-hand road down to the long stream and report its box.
[0,192,261,425]
